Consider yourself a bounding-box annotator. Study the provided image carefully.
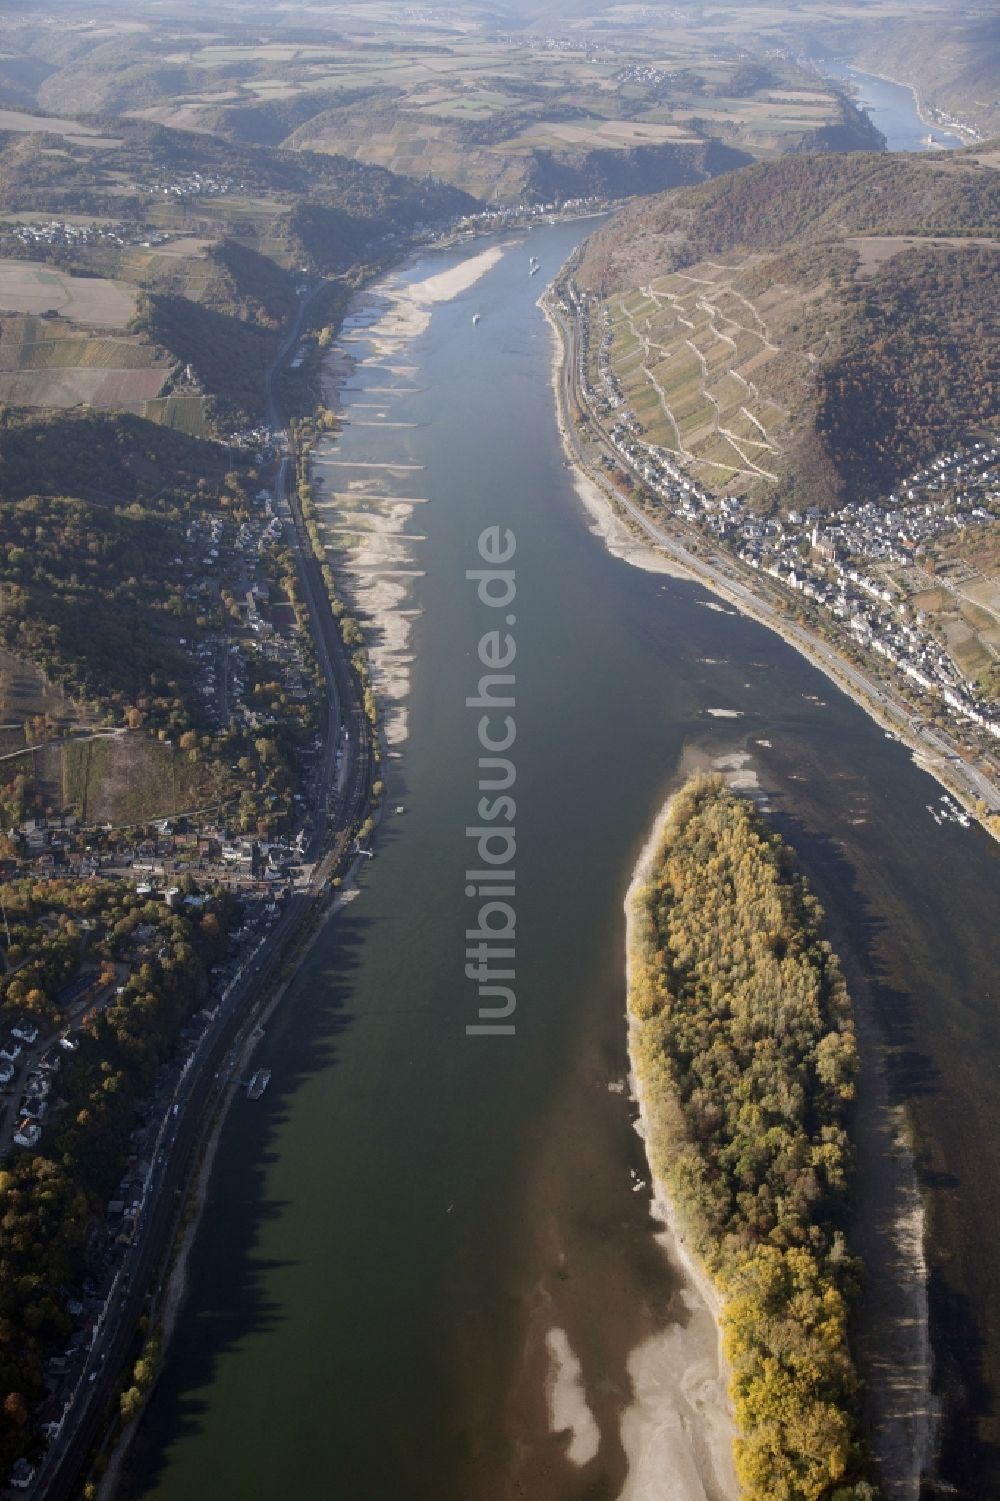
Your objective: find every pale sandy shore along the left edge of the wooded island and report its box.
[620,796,739,1501]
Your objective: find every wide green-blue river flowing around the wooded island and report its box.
[126,187,1000,1501]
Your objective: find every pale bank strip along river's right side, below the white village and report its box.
[539,288,1000,842]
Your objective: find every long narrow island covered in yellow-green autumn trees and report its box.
[629,776,878,1501]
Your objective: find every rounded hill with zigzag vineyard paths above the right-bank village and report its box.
[578,150,1000,507]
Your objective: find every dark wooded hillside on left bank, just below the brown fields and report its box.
[0,417,240,731]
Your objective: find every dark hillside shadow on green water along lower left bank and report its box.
[117,911,369,1498]
